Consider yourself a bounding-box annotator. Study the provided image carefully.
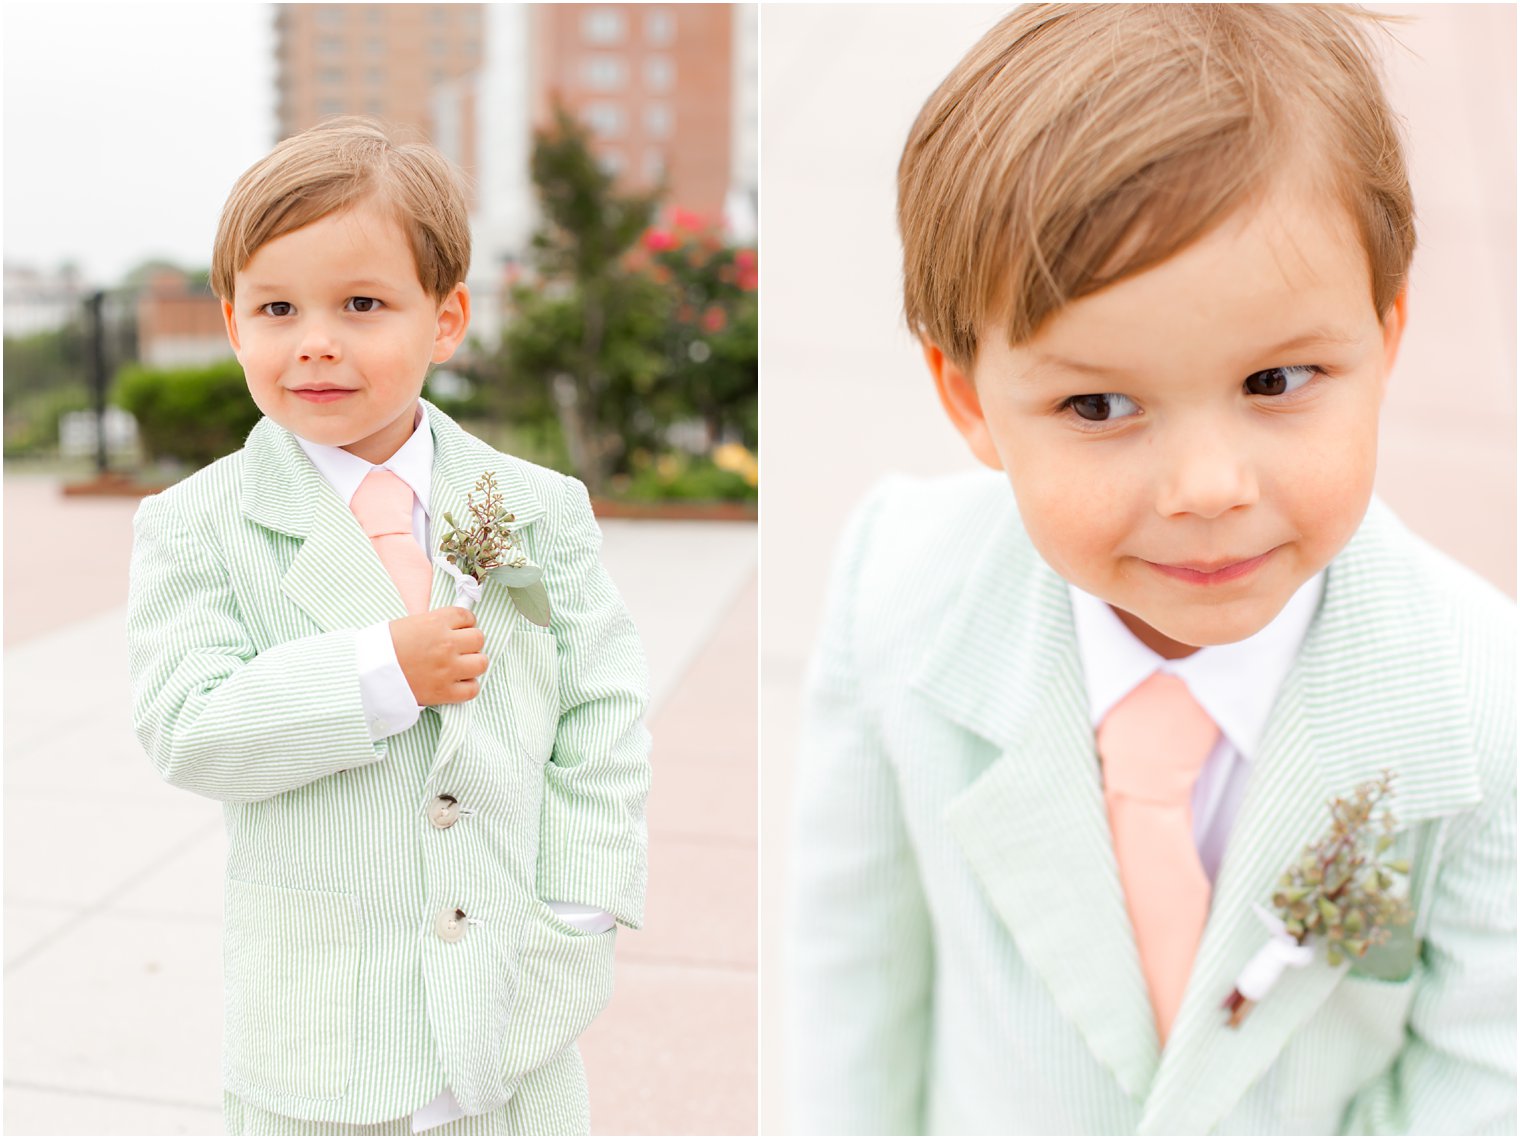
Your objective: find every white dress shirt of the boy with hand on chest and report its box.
[295,403,616,1134]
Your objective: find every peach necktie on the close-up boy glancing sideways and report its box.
[1097,672,1219,1045]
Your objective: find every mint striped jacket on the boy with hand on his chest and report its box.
[128,406,649,1130]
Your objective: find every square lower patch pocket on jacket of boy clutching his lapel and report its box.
[223,879,359,1099]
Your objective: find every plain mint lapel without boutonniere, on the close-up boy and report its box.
[915,519,1158,1099]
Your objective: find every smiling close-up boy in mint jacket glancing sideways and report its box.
[789,5,1515,1134]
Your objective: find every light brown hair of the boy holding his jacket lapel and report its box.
[211,116,470,301]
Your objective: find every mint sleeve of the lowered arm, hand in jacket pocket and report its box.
[538,479,649,929]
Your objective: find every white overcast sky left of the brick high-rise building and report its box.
[0,0,275,284]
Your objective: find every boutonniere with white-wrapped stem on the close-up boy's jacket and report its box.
[1221,771,1414,1028]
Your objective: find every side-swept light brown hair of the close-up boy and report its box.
[897,5,1415,368]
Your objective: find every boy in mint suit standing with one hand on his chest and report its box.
[128,120,649,1134]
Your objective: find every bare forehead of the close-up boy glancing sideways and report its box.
[1021,187,1377,363]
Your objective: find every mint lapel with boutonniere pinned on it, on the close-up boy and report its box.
[1138,502,1480,1134]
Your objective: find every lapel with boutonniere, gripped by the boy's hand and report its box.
[424,401,544,779]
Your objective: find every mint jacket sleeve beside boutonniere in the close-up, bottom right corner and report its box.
[1341,792,1515,1134]
